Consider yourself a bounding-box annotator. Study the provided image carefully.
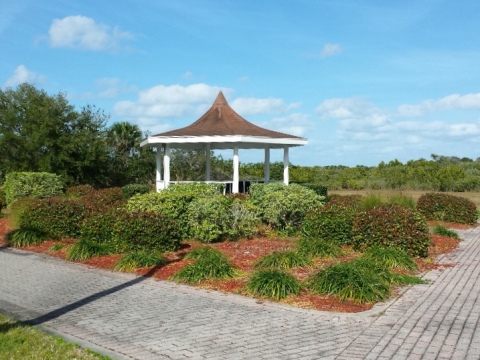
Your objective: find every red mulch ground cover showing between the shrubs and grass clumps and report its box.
[0,218,472,313]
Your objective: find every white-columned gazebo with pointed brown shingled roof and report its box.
[141,91,308,193]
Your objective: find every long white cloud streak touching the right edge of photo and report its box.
[397,93,480,116]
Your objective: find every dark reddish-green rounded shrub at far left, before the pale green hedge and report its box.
[20,198,87,239]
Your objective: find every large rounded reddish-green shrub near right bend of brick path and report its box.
[352,205,431,257]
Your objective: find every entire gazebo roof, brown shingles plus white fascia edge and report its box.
[141,91,307,149]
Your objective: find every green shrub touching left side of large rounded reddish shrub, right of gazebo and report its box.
[302,196,360,245]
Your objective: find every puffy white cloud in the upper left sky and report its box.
[49,15,133,51]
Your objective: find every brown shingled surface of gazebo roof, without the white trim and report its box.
[154,91,301,139]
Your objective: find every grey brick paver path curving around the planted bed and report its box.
[0,228,480,359]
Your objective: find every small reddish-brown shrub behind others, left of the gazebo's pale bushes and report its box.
[79,187,126,214]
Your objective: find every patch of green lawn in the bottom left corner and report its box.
[0,315,109,360]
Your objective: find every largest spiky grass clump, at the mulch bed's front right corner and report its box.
[305,259,392,304]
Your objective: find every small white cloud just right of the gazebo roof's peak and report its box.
[230,98,300,116]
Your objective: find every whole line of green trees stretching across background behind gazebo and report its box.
[0,83,480,191]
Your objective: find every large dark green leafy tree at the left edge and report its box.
[0,83,108,186]
